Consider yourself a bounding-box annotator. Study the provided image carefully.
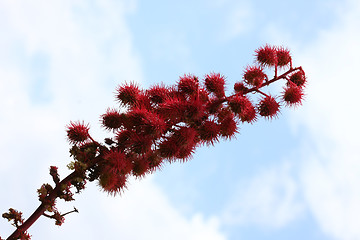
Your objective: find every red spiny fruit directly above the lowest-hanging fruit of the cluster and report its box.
[103,149,132,175]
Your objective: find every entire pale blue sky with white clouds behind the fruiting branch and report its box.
[0,0,360,240]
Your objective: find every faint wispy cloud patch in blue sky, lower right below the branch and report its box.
[223,163,303,228]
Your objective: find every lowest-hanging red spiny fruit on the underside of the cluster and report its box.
[99,172,127,196]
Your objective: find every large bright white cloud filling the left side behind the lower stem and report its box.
[0,0,225,239]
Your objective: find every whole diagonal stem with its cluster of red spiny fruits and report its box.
[3,45,306,239]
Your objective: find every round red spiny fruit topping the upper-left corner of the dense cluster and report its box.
[116,83,141,106]
